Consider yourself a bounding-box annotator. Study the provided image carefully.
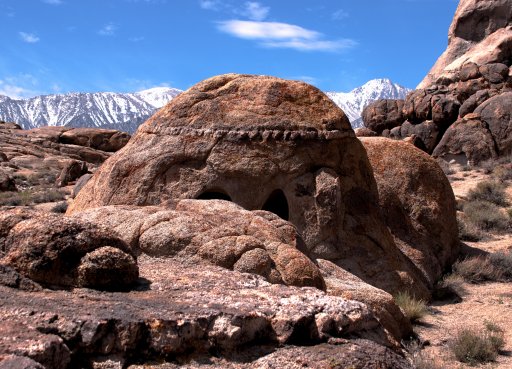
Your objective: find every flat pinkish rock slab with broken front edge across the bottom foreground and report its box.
[0,256,401,368]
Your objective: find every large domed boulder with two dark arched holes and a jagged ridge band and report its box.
[68,74,428,296]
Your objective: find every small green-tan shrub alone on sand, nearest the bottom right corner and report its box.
[450,323,505,365]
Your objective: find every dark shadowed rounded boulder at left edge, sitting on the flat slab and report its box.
[0,210,138,290]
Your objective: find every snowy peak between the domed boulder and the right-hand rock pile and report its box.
[326,79,412,128]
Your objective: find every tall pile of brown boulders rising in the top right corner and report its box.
[360,0,512,163]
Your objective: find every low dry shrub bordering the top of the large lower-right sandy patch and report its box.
[453,256,502,283]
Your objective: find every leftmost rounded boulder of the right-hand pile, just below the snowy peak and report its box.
[362,100,405,134]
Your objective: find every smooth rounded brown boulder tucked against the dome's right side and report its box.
[361,137,459,287]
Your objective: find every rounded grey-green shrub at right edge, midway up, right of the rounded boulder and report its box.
[464,201,510,231]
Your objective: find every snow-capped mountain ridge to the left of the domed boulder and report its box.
[0,87,181,131]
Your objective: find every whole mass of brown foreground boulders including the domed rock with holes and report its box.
[0,74,459,368]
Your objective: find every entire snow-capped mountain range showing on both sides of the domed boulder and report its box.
[0,79,411,133]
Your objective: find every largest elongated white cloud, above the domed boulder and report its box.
[218,20,357,51]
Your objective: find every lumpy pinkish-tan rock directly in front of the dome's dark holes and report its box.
[73,200,325,289]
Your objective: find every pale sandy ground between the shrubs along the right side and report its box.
[415,165,512,369]
